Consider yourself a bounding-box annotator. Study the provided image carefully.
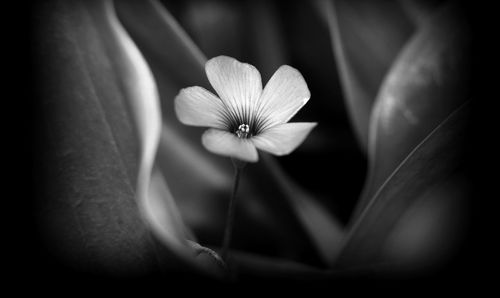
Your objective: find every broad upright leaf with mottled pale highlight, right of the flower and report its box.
[353,1,471,217]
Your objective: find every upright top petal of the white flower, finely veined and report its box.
[205,56,262,122]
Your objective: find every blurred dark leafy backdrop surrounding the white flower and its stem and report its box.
[31,0,480,284]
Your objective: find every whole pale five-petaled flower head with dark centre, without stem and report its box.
[175,56,317,162]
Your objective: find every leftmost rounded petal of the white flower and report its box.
[175,86,225,128]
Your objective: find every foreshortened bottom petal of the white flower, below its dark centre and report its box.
[201,128,259,162]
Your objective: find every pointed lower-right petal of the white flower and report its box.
[252,122,317,156]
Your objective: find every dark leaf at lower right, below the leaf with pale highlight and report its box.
[336,104,470,269]
